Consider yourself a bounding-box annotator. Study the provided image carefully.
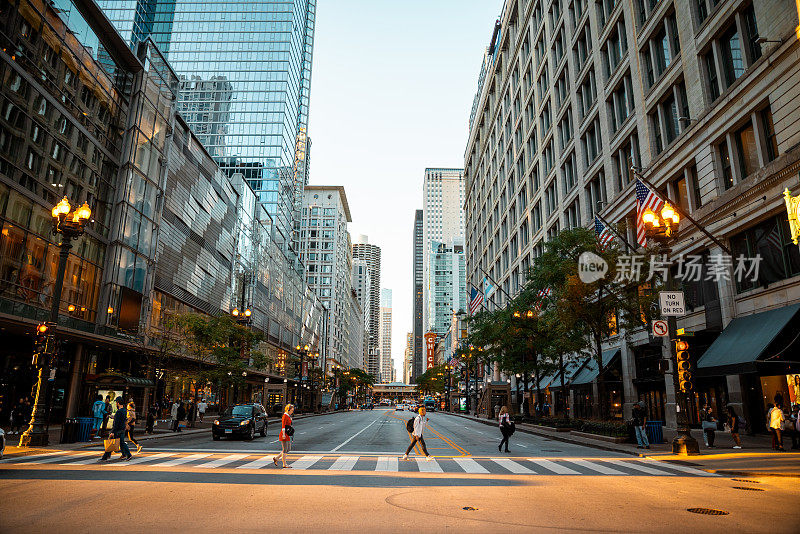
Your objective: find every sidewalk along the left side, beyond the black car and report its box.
[3,410,342,456]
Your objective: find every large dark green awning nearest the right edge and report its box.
[697,304,800,370]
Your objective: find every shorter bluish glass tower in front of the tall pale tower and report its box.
[425,239,467,336]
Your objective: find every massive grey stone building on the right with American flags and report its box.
[464,0,800,428]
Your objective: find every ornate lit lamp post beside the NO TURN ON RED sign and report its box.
[642,203,700,454]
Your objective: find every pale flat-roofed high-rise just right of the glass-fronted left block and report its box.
[300,185,363,370]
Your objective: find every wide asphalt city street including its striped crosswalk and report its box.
[0,409,800,532]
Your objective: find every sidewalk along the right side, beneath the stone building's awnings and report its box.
[440,412,800,477]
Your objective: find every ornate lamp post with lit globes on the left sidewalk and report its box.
[19,197,92,447]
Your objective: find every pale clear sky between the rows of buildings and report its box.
[308,0,503,380]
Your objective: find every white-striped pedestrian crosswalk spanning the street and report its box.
[0,451,718,477]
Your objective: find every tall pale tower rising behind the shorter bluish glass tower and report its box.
[422,168,466,333]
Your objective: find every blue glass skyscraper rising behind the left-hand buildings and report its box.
[98,0,316,240]
